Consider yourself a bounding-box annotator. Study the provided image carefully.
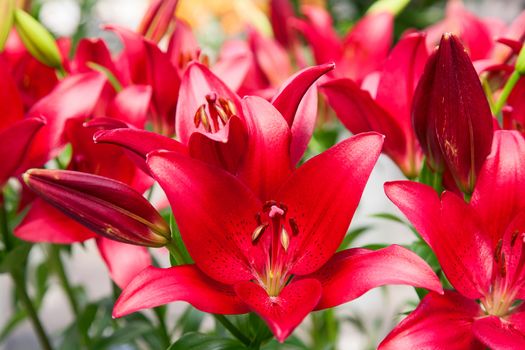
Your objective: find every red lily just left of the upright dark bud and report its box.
[321,34,428,178]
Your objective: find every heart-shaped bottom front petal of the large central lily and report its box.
[235,278,322,342]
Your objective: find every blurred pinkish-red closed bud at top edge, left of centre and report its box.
[137,0,179,43]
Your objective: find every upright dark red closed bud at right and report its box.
[412,34,493,193]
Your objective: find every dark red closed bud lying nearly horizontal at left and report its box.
[23,169,171,247]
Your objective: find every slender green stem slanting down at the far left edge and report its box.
[0,193,53,350]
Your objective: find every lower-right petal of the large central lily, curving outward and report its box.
[307,245,443,310]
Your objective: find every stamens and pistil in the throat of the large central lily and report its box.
[252,201,299,297]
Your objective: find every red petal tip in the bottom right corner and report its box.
[473,316,525,349]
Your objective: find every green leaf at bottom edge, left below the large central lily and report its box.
[168,333,246,350]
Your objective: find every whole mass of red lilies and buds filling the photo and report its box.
[0,0,525,349]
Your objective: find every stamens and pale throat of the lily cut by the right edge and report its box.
[481,231,525,317]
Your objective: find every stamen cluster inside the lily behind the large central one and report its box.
[193,92,237,133]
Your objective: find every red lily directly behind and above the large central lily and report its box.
[96,62,333,194]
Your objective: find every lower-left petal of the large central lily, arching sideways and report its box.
[113,265,248,317]
